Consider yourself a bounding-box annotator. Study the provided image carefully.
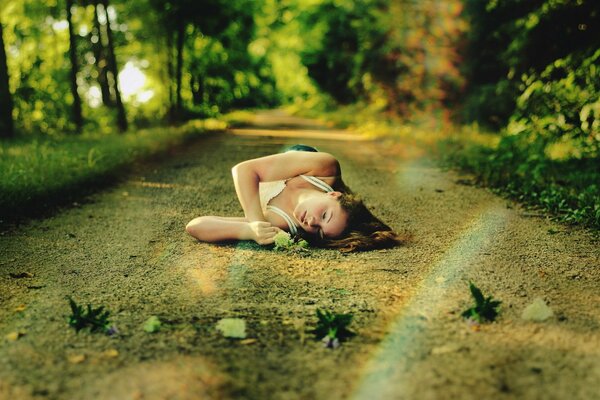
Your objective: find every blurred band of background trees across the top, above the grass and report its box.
[0,0,600,158]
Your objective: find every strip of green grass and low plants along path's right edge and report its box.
[438,135,600,230]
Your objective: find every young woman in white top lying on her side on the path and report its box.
[186,145,402,251]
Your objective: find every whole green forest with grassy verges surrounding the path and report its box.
[0,0,600,227]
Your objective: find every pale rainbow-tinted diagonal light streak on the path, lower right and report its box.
[352,208,506,400]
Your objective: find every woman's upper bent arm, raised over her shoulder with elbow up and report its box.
[231,151,340,221]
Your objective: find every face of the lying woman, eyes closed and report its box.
[293,192,348,239]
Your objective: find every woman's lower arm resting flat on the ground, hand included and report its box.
[185,216,280,244]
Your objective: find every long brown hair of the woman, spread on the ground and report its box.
[307,193,409,252]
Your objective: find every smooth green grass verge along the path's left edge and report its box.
[0,120,225,221]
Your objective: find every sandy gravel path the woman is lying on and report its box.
[0,113,600,399]
